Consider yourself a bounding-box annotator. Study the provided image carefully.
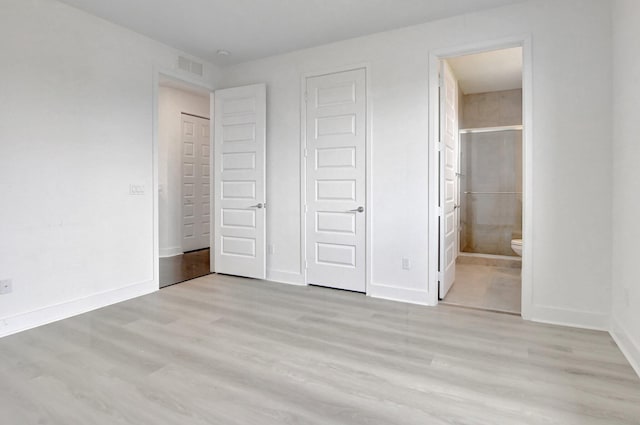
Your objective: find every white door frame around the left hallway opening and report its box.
[151,67,215,288]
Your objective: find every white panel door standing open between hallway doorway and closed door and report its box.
[214,84,267,279]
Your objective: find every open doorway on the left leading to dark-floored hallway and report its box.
[157,77,212,288]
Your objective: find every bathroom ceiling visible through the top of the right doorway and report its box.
[447,47,522,94]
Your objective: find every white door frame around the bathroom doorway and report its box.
[427,34,534,320]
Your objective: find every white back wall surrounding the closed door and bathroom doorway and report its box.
[222,0,611,328]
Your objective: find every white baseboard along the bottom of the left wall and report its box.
[0,281,158,338]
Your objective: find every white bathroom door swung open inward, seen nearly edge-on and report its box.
[439,61,459,299]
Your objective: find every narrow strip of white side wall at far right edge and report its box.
[612,0,640,374]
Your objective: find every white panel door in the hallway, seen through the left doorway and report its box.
[181,114,211,252]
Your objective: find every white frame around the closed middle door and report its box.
[300,62,373,296]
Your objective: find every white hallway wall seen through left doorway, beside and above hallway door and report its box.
[158,87,210,253]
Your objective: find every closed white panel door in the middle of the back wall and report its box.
[305,69,366,292]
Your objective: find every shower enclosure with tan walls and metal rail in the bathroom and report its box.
[459,126,522,256]
